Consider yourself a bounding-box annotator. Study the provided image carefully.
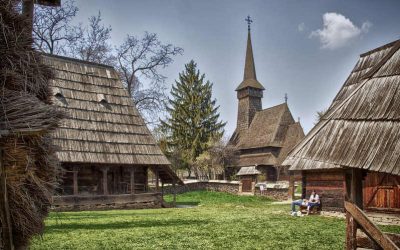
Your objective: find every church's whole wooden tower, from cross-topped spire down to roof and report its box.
[236,16,264,133]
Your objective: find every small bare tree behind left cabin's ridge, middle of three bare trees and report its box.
[70,11,112,64]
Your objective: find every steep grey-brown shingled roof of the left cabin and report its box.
[43,55,170,165]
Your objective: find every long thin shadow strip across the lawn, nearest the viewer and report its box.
[46,219,209,233]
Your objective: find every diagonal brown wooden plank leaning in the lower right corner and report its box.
[344,201,400,250]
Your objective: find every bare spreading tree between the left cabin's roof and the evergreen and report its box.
[115,32,183,123]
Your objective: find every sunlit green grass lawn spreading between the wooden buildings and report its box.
[31,191,400,250]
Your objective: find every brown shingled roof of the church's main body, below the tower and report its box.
[234,103,304,166]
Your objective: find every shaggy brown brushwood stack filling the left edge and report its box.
[0,0,63,249]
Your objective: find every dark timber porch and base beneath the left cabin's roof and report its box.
[52,164,183,211]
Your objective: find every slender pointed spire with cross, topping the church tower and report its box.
[236,16,264,91]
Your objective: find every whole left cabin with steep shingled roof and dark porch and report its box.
[43,55,183,210]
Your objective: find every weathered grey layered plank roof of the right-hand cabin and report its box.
[284,40,400,175]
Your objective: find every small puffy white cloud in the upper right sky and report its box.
[310,12,372,50]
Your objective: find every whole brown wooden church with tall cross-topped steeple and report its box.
[230,17,304,192]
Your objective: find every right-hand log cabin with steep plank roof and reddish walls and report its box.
[284,40,400,213]
